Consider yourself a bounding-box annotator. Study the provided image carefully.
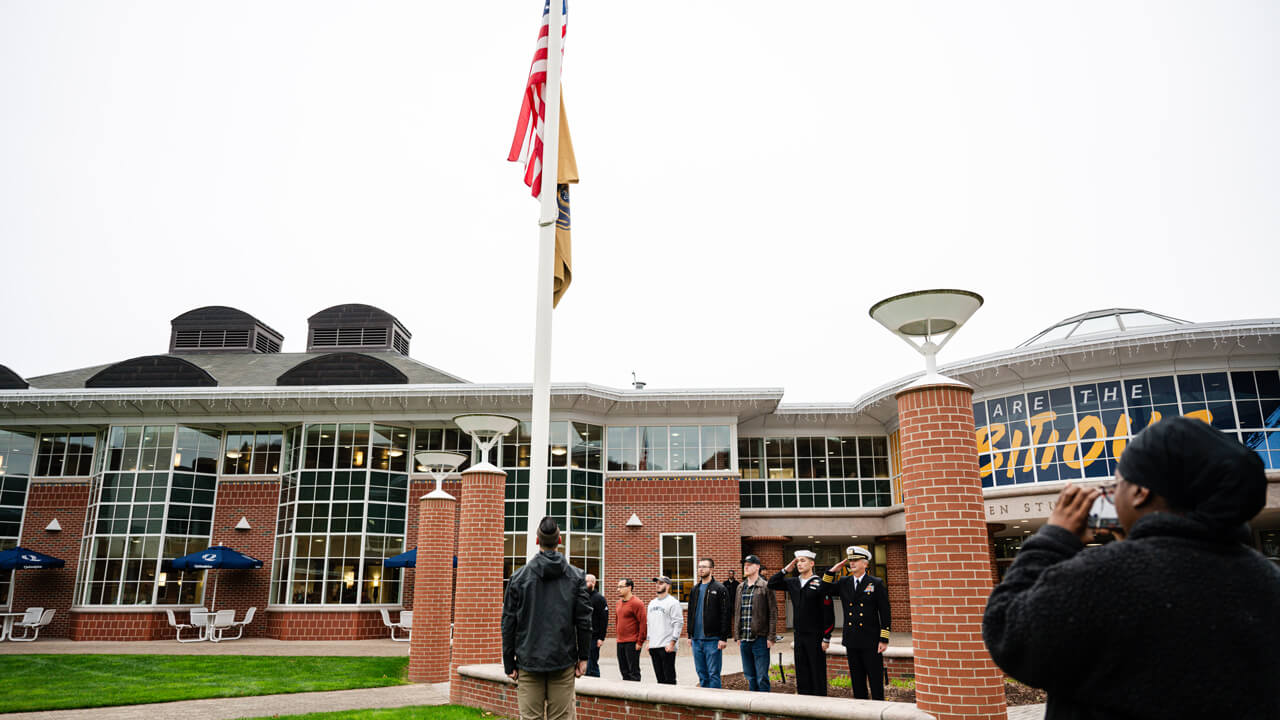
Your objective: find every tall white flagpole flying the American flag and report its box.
[525,0,563,557]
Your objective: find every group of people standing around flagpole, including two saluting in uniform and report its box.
[502,518,890,719]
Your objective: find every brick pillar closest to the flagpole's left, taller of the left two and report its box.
[453,462,507,705]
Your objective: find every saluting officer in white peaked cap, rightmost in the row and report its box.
[822,546,890,700]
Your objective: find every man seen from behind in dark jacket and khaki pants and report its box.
[502,518,591,720]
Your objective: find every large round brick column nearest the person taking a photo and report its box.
[897,383,1007,720]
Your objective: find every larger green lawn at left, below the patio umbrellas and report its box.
[0,655,409,717]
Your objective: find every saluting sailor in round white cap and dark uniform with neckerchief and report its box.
[769,550,836,696]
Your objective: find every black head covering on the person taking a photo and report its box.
[1119,418,1267,530]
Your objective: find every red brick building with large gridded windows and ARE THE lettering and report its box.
[0,305,1280,639]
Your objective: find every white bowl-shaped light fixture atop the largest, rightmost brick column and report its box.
[869,290,982,384]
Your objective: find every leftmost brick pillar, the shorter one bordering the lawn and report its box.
[408,491,460,683]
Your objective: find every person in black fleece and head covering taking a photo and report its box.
[982,418,1280,720]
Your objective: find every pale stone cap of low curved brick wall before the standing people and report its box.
[458,665,933,720]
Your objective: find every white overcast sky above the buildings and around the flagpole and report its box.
[0,0,1280,402]
